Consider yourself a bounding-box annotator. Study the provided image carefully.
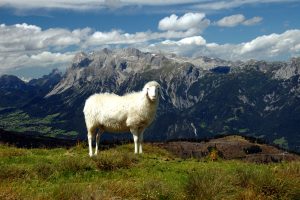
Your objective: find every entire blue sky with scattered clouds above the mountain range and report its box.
[0,0,300,78]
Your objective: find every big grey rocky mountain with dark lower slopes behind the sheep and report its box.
[1,48,300,151]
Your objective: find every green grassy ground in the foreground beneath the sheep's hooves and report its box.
[0,144,300,200]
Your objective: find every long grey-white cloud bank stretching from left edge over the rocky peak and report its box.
[0,19,207,73]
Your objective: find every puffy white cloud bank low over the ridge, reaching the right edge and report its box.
[148,29,300,60]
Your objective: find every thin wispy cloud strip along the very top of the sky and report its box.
[0,0,299,12]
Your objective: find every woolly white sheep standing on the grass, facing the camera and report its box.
[83,81,162,156]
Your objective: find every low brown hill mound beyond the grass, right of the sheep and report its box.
[157,135,300,163]
